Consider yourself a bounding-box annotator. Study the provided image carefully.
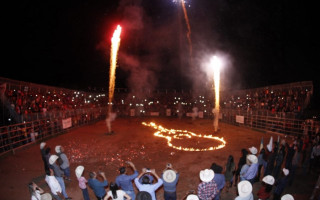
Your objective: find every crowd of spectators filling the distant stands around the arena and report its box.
[3,79,313,122]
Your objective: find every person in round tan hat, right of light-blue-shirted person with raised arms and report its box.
[161,163,180,200]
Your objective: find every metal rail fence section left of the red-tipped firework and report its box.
[0,108,106,156]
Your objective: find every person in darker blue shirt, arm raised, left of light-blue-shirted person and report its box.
[116,161,138,199]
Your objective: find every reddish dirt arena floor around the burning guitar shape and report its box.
[0,118,319,200]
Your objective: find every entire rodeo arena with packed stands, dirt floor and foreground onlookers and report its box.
[0,75,320,200]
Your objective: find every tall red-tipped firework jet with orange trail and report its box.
[108,25,121,115]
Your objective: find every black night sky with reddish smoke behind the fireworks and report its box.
[0,0,320,90]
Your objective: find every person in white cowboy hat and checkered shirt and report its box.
[198,169,219,200]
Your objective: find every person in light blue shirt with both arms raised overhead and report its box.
[134,168,163,200]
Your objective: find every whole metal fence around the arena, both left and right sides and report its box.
[0,108,319,156]
